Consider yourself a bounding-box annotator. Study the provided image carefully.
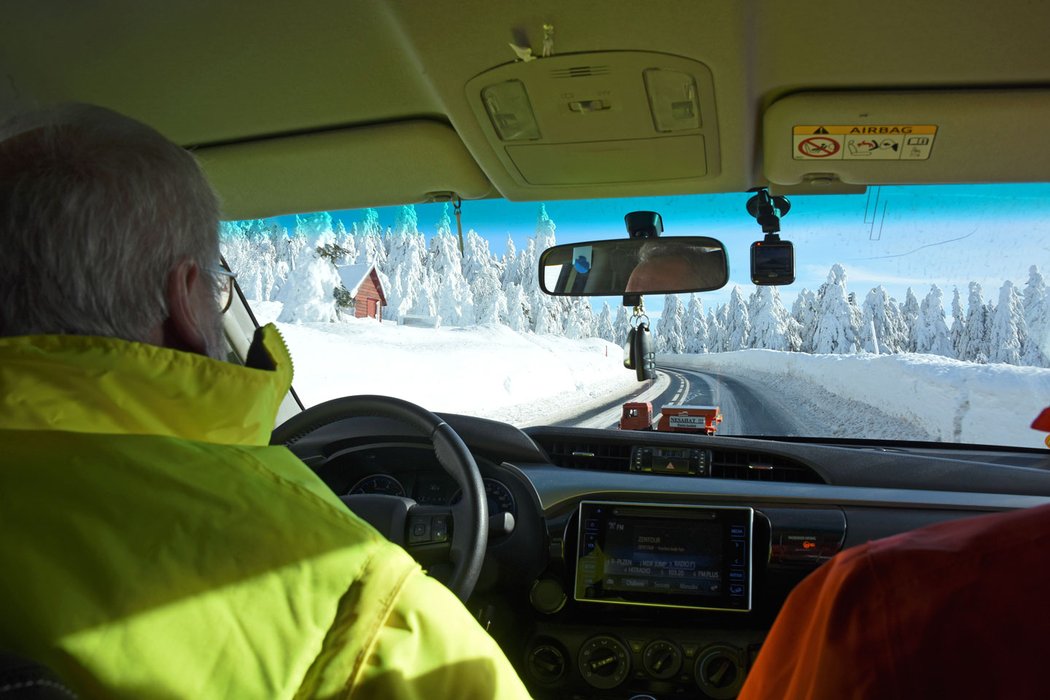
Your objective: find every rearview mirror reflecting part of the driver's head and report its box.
[540,236,729,297]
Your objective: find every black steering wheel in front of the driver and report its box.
[270,395,488,601]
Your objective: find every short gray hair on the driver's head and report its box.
[0,105,218,341]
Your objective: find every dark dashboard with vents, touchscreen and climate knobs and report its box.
[290,415,1050,700]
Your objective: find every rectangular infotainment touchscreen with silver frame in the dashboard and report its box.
[575,501,754,611]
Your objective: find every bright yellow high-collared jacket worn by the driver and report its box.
[0,326,527,700]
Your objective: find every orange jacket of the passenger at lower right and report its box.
[739,506,1050,700]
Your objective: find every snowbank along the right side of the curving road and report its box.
[673,349,1050,447]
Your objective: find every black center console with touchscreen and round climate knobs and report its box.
[523,500,845,700]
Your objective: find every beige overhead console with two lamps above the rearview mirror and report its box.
[466,51,720,199]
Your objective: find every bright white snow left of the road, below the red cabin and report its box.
[264,303,637,427]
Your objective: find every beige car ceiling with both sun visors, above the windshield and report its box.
[0,0,1050,217]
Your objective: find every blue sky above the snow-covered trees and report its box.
[270,184,1050,311]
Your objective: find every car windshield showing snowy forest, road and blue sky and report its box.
[223,185,1050,447]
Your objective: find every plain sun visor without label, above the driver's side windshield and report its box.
[195,120,496,219]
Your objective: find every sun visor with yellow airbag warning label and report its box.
[762,89,1050,188]
